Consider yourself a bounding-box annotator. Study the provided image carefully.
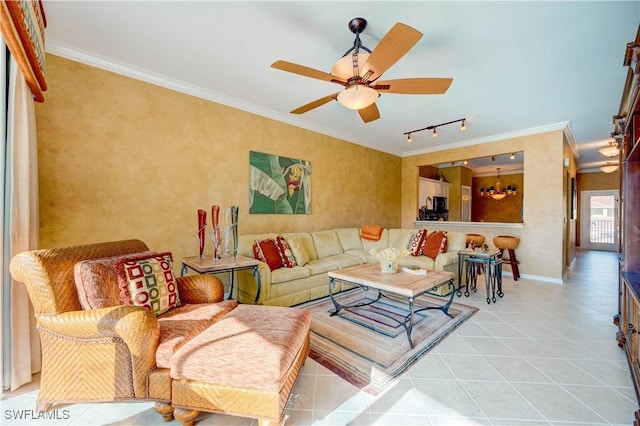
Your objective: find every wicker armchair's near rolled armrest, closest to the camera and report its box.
[37,306,160,356]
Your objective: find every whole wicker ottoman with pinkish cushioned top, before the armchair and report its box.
[171,305,311,425]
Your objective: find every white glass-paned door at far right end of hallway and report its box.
[580,190,618,251]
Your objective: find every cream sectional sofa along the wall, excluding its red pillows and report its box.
[237,227,466,306]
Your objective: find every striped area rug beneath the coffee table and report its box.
[297,288,478,395]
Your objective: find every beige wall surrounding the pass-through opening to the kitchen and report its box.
[402,130,566,282]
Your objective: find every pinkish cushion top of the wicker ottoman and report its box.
[170,305,311,395]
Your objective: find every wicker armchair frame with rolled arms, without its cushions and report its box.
[10,240,224,420]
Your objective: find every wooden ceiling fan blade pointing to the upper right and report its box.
[360,22,422,82]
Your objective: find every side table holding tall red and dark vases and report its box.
[180,254,262,305]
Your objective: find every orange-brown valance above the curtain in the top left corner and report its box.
[0,0,47,102]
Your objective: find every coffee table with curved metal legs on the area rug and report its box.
[328,262,455,349]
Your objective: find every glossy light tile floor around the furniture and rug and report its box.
[0,251,638,426]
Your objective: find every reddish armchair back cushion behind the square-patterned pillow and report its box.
[73,251,155,309]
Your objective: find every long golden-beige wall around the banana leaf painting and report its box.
[36,55,401,261]
